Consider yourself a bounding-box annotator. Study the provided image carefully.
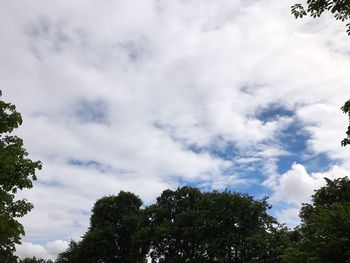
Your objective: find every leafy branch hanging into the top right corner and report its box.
[292,0,350,35]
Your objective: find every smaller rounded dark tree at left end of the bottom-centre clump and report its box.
[56,191,148,263]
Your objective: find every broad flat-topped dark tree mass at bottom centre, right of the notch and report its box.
[146,187,287,262]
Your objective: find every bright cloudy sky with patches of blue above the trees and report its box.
[0,0,350,259]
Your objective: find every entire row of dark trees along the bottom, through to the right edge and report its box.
[41,177,350,263]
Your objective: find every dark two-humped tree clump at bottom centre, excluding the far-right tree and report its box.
[56,187,288,263]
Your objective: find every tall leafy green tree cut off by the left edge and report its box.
[0,91,41,262]
